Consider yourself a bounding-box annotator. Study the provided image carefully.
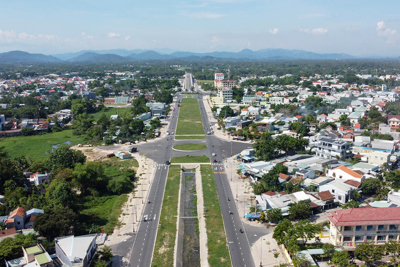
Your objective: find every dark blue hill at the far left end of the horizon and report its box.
[0,51,62,64]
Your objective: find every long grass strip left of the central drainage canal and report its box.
[151,165,181,267]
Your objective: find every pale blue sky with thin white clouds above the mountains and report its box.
[0,0,400,57]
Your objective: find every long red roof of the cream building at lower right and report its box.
[328,207,400,226]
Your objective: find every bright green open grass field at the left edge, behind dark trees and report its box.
[0,130,84,161]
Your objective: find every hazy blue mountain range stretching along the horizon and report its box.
[0,49,355,64]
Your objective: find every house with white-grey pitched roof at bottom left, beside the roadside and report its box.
[54,234,97,267]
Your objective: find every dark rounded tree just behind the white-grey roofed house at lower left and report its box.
[33,208,77,241]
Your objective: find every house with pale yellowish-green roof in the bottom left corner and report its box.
[6,244,55,267]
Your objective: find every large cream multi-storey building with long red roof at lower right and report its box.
[328,207,400,249]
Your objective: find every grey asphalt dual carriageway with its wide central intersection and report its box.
[113,91,268,267]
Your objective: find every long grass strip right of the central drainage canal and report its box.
[200,165,232,267]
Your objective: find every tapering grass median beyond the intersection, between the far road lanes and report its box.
[176,98,205,135]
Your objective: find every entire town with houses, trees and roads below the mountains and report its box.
[0,61,400,267]
